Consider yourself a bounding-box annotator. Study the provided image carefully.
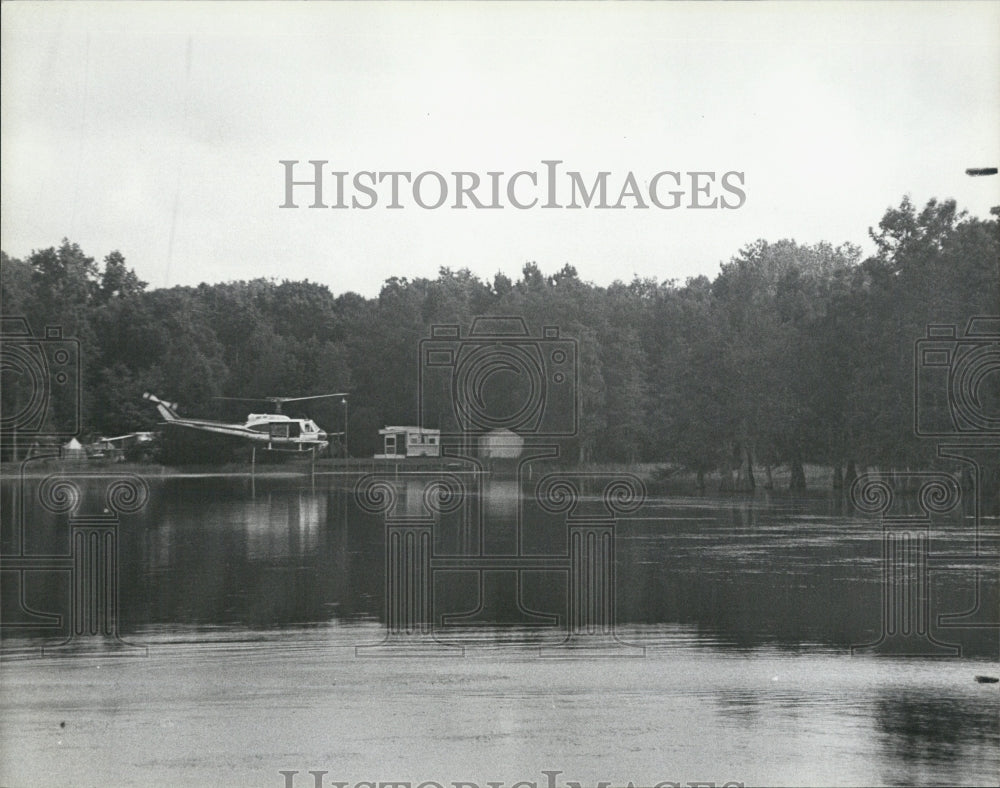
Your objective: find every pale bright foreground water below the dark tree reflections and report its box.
[0,627,997,788]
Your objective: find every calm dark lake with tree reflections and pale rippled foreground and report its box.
[0,462,1000,788]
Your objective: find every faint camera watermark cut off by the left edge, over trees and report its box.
[0,317,81,441]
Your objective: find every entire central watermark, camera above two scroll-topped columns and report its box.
[355,315,645,656]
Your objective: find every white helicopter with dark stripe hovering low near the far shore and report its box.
[142,391,347,453]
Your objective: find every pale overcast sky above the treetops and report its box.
[0,0,1000,296]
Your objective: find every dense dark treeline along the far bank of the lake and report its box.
[2,194,1000,488]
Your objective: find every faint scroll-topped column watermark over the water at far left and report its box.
[0,456,149,656]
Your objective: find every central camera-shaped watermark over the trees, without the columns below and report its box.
[418,316,579,438]
